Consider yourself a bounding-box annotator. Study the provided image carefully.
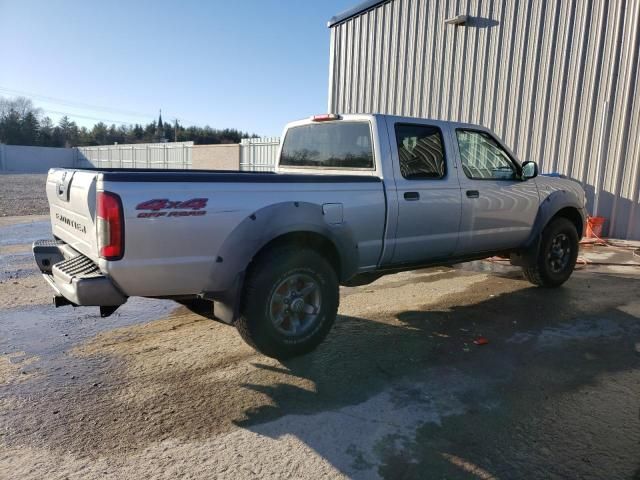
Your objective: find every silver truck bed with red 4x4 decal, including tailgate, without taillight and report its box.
[47,168,386,296]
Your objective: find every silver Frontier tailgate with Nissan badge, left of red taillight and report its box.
[47,169,99,262]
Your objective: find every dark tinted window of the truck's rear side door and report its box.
[396,124,447,180]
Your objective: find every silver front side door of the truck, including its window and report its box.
[452,128,538,255]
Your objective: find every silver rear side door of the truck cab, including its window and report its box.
[387,119,461,264]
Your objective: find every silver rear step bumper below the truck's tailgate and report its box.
[32,240,127,307]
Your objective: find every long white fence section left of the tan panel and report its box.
[78,142,193,169]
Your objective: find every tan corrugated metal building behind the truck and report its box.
[329,0,640,239]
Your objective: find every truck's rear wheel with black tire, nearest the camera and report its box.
[236,245,339,359]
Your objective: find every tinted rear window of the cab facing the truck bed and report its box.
[280,121,375,170]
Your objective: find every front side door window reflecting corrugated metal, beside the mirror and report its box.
[456,129,517,180]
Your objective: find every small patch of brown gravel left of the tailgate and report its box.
[0,173,49,217]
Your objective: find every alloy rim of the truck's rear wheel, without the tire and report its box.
[269,273,322,337]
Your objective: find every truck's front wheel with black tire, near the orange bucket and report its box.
[522,218,580,288]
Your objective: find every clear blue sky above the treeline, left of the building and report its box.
[0,0,360,136]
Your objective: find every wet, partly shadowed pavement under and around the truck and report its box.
[0,218,640,479]
